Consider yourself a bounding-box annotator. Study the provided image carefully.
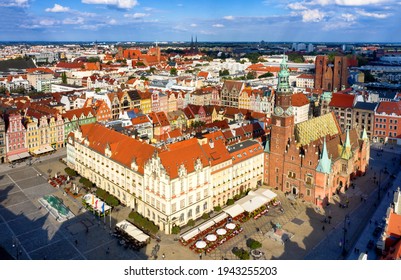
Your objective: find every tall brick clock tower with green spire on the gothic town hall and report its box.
[271,55,294,152]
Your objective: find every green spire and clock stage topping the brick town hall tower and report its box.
[274,54,294,116]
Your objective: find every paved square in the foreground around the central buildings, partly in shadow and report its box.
[0,142,401,260]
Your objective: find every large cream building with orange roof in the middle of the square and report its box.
[67,124,263,233]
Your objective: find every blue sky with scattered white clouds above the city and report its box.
[0,0,401,42]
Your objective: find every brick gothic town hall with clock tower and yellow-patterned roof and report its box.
[264,55,369,206]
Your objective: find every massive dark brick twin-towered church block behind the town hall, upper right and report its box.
[315,55,348,91]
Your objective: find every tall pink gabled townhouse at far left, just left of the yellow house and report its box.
[6,114,28,158]
